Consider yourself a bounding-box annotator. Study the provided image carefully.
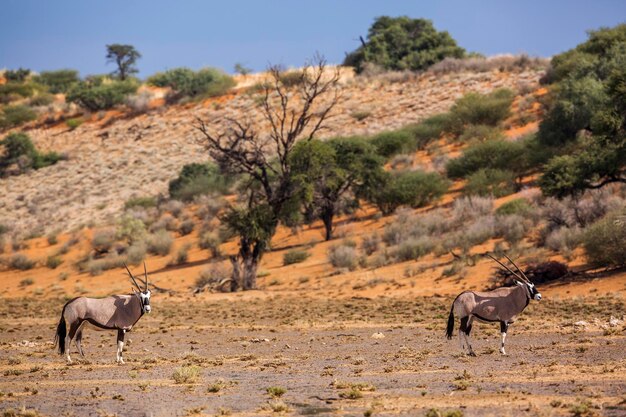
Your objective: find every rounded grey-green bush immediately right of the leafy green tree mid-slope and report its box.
[369,171,449,215]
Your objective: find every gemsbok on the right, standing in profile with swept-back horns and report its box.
[446,254,541,356]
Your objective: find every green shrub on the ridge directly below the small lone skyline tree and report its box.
[66,77,138,111]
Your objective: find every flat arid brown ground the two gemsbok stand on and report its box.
[0,292,626,416]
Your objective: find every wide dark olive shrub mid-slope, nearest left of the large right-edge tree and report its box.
[446,140,526,178]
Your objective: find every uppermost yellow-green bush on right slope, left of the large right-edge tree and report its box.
[449,89,515,135]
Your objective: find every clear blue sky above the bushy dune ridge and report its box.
[0,0,626,77]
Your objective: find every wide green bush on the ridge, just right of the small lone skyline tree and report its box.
[147,68,235,100]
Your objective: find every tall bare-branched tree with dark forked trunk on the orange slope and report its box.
[195,56,339,290]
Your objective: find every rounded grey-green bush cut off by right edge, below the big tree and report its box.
[582,210,626,267]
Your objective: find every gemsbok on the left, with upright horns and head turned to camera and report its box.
[54,262,151,364]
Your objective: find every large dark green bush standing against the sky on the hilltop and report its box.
[344,16,465,73]
